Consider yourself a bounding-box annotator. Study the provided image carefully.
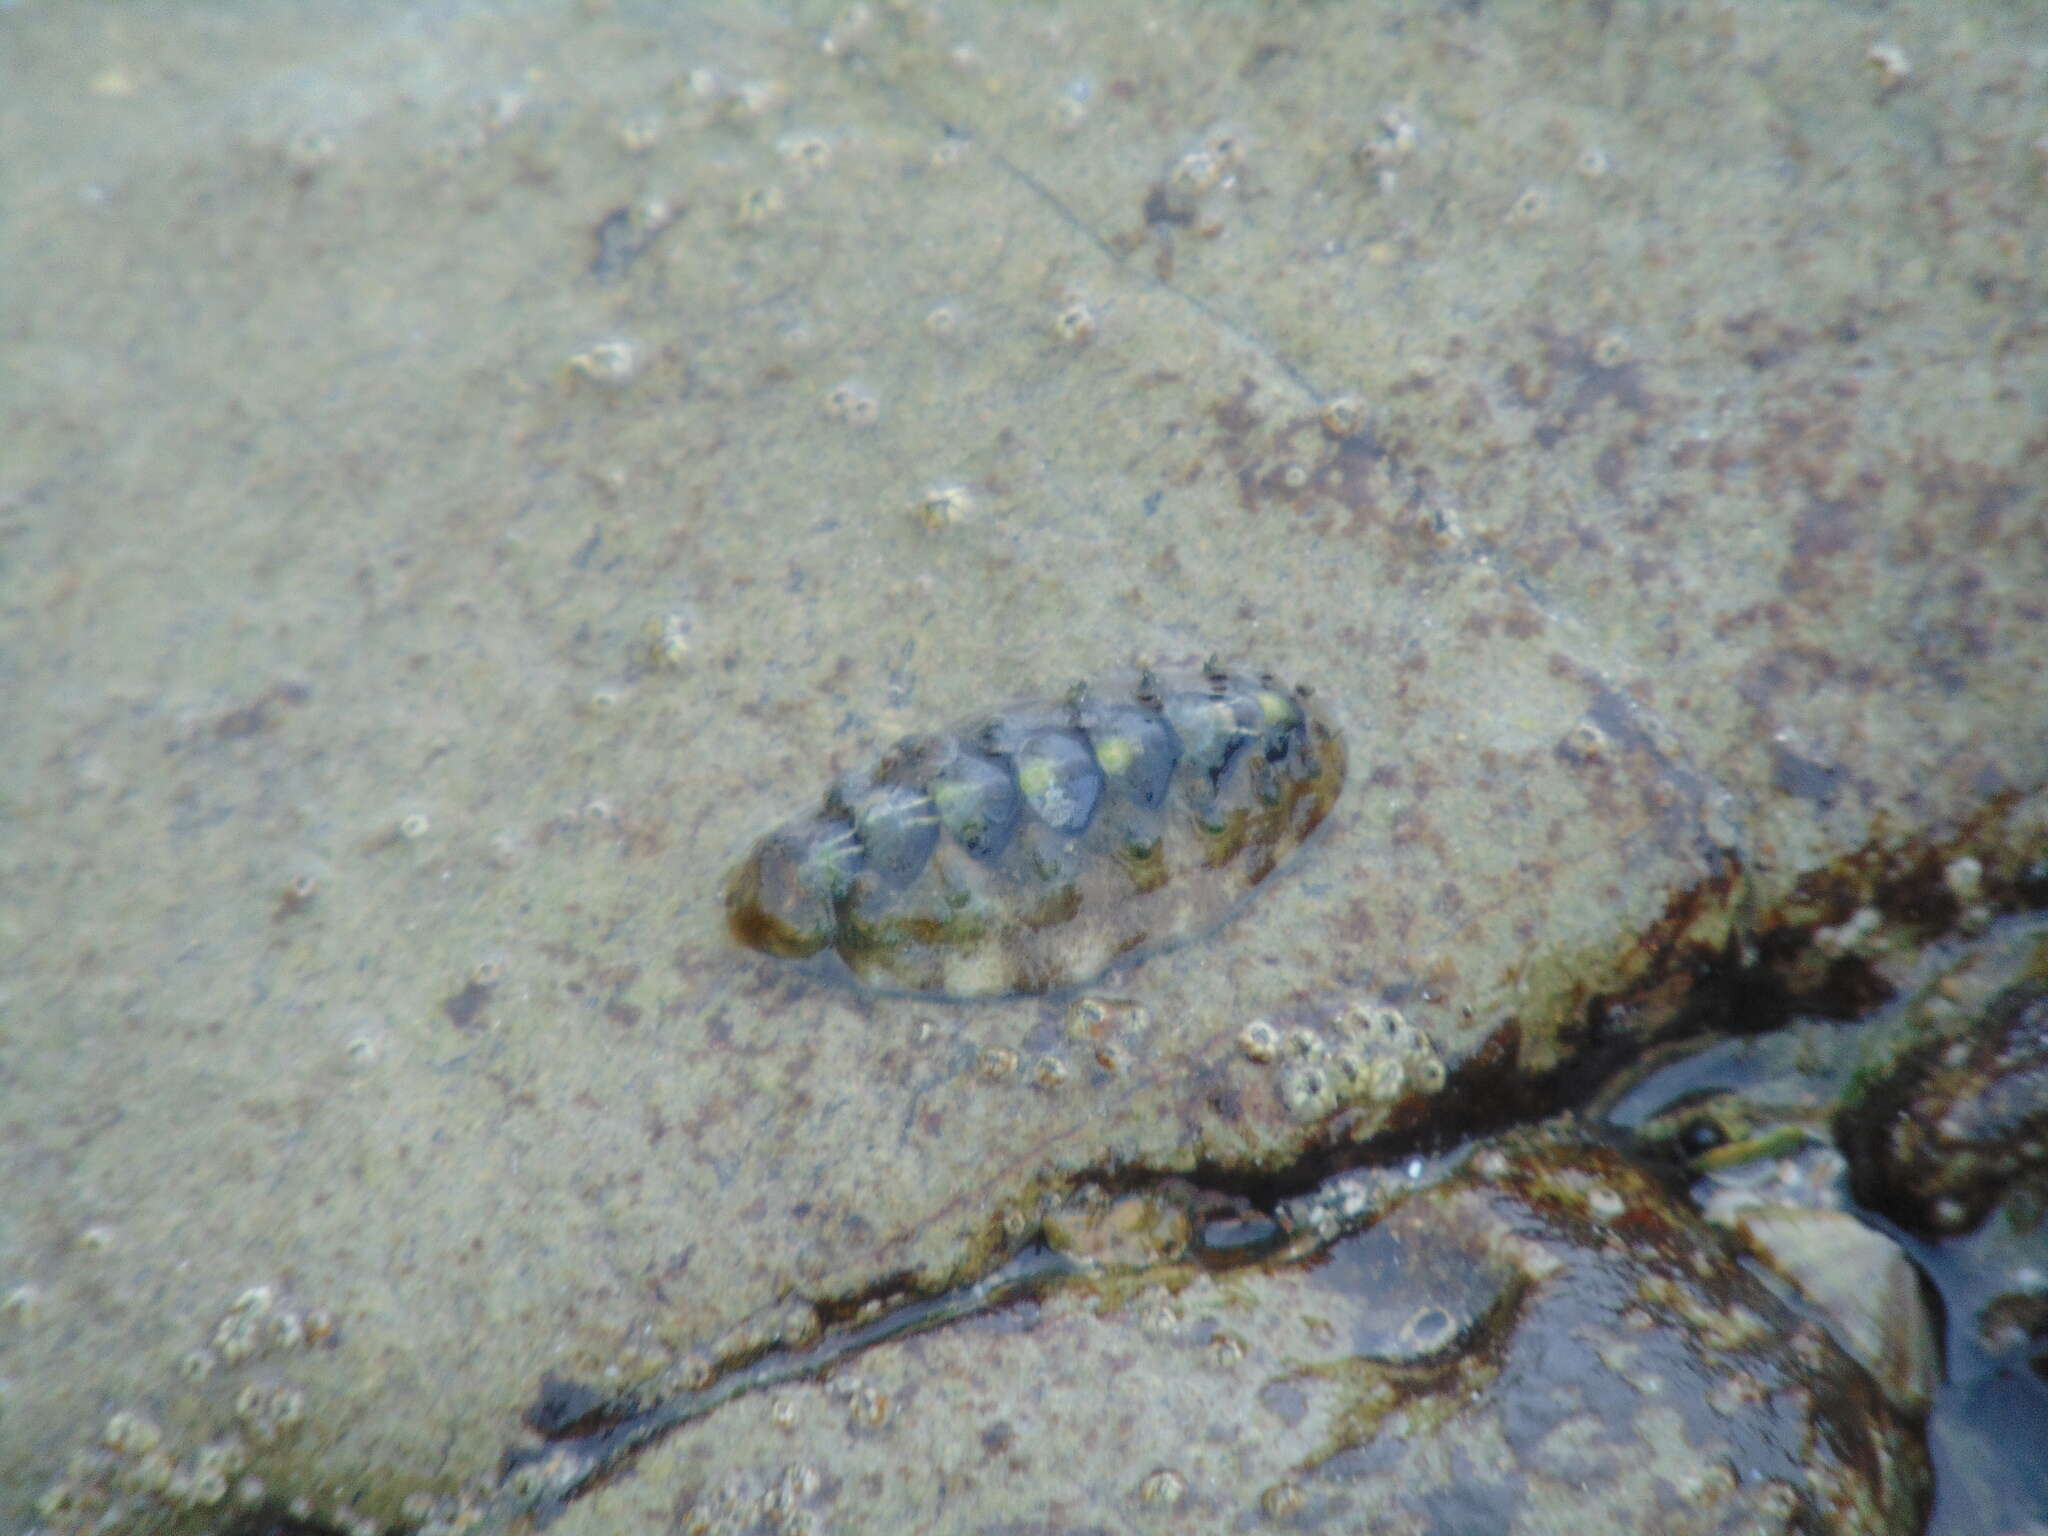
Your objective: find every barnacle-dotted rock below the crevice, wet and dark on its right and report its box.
[557,1126,1927,1532]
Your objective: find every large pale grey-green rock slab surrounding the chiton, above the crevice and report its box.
[0,0,2048,1530]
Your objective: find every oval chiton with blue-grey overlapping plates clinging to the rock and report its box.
[725,664,1343,997]
